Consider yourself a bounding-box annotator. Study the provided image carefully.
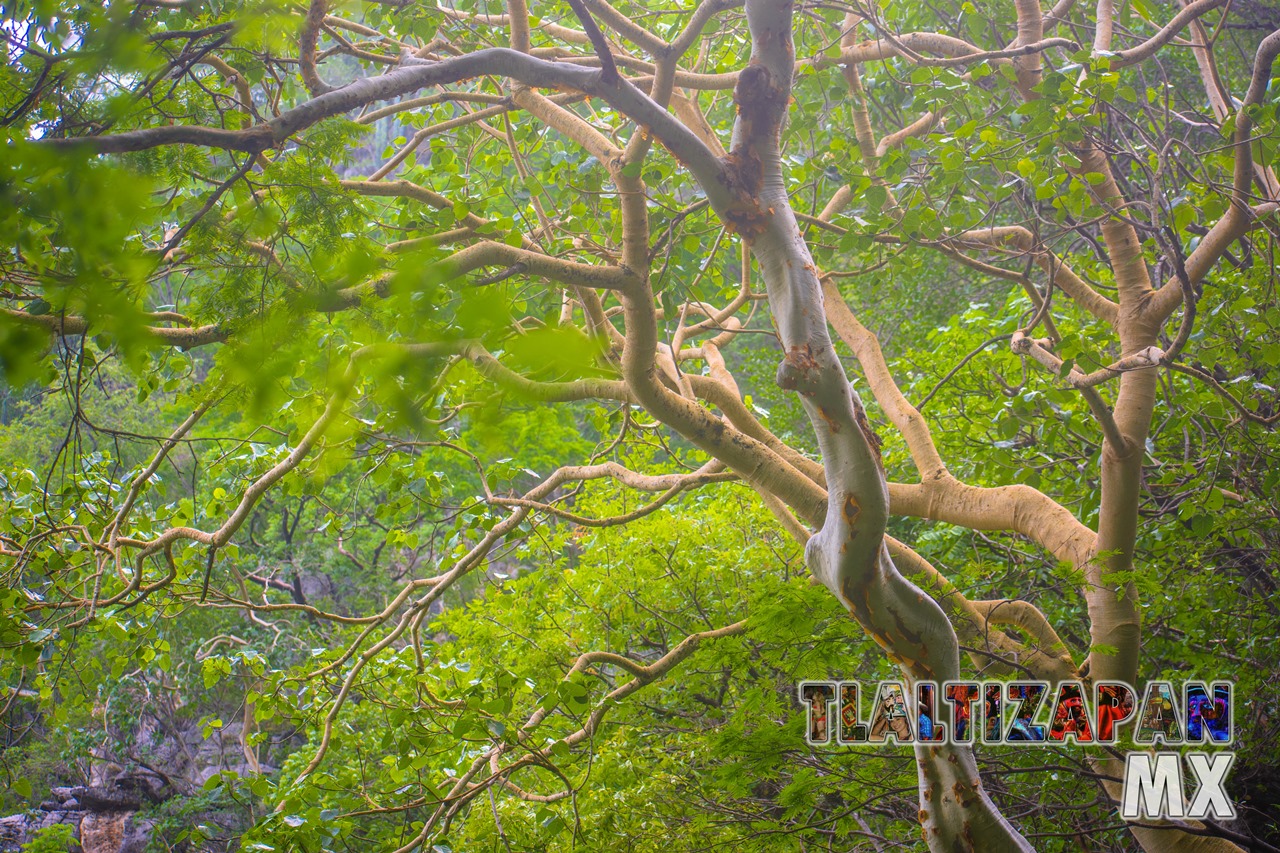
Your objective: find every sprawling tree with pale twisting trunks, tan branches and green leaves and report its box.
[0,0,1280,850]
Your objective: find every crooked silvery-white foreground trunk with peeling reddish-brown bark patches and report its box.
[730,0,1032,850]
